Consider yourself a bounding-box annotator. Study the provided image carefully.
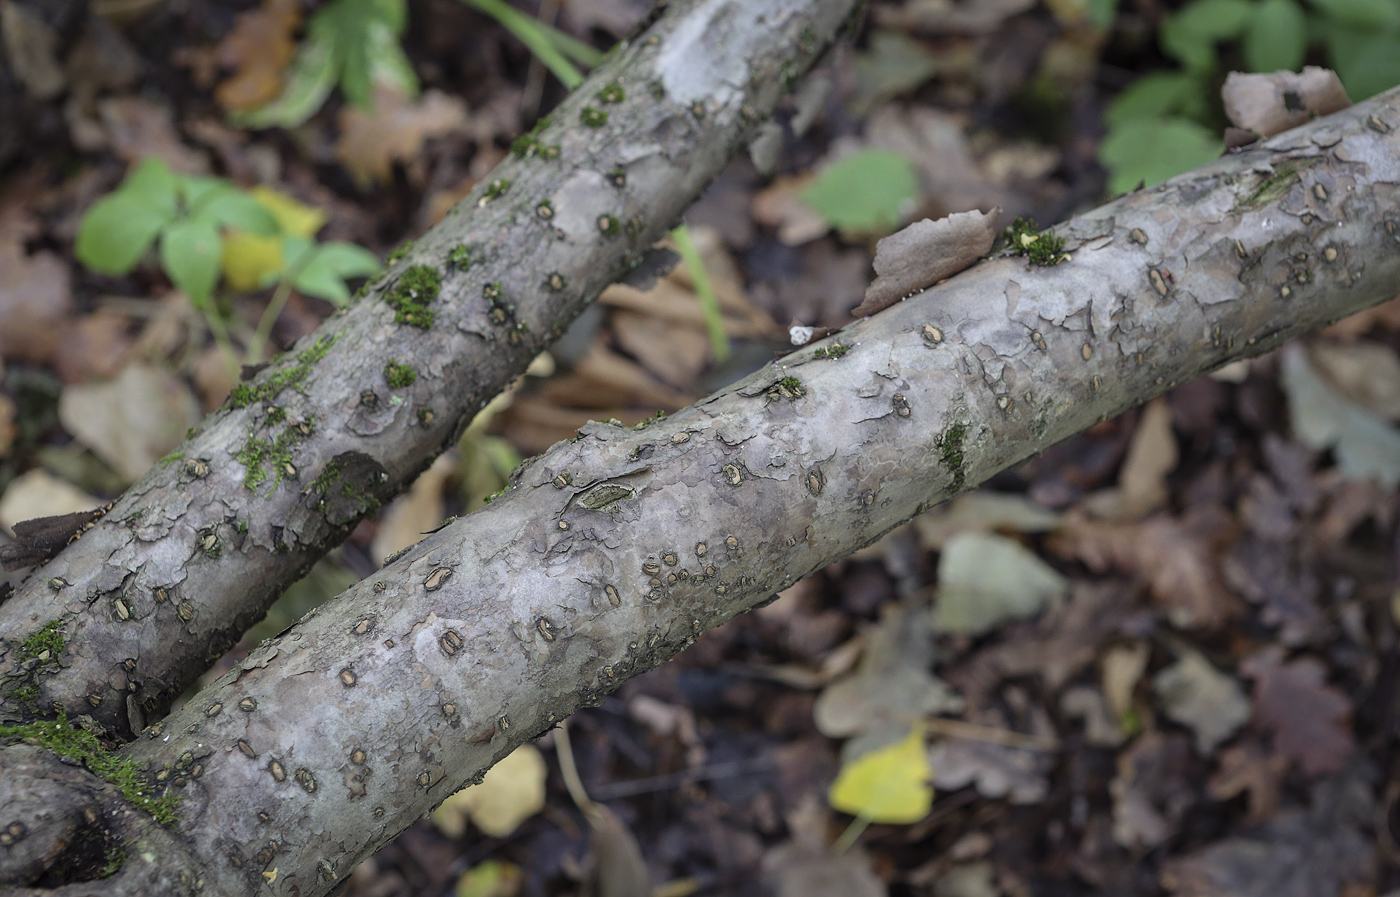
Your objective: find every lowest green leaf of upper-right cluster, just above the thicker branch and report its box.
[1099,118,1224,193]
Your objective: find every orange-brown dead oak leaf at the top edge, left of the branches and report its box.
[214,0,301,112]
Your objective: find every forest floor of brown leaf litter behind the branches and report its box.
[0,0,1400,897]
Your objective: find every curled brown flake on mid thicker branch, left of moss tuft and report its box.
[851,209,1001,318]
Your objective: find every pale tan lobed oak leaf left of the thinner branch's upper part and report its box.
[336,85,468,186]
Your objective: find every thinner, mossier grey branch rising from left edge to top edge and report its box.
[0,0,855,740]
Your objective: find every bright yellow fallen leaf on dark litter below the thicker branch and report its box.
[827,725,934,824]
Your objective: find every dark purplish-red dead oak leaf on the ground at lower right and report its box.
[1240,648,1357,777]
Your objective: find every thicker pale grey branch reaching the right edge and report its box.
[8,20,1400,896]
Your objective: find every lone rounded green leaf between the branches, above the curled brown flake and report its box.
[802,150,918,234]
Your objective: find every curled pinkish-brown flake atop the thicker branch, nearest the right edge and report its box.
[1221,66,1351,137]
